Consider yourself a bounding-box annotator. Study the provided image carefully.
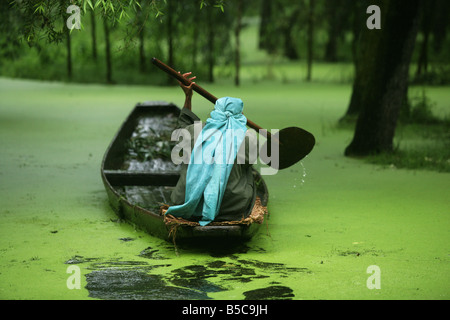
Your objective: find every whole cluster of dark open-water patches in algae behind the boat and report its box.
[80,247,311,300]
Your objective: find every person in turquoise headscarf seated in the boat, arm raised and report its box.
[166,72,256,226]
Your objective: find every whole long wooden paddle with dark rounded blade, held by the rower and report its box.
[152,58,316,170]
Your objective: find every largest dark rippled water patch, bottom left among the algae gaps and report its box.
[86,268,209,300]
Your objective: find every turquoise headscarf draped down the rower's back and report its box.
[166,97,247,226]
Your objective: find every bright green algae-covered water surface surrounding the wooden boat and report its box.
[0,79,450,300]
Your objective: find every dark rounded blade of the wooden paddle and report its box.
[261,127,316,170]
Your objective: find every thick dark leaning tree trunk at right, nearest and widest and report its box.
[345,0,420,156]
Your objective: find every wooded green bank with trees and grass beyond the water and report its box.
[0,0,450,171]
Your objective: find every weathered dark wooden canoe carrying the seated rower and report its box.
[101,101,269,243]
